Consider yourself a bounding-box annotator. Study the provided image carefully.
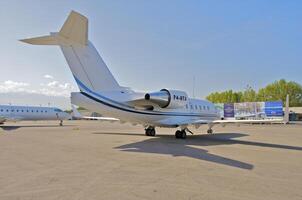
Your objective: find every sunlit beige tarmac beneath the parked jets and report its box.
[0,121,302,200]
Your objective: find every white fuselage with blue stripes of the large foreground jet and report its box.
[71,89,219,127]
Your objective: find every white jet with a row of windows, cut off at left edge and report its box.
[0,105,70,126]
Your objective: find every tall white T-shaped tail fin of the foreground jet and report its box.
[21,11,122,92]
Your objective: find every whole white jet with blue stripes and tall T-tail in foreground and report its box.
[21,11,286,138]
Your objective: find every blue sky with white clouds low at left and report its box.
[0,0,302,108]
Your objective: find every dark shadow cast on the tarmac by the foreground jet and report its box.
[94,132,302,170]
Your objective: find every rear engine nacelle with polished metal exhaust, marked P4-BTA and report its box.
[145,89,188,109]
